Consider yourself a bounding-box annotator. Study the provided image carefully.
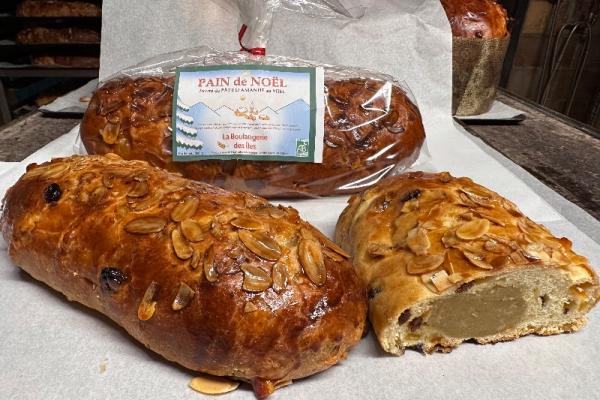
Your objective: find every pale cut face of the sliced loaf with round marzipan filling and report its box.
[379,266,598,354]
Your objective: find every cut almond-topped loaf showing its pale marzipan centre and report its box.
[336,173,600,354]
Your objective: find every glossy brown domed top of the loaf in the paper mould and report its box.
[441,0,508,39]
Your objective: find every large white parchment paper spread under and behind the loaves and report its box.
[0,0,600,400]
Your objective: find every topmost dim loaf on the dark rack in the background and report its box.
[17,0,102,17]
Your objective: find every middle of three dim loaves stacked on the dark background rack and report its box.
[16,26,100,44]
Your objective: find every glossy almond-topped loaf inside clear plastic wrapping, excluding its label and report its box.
[81,77,425,197]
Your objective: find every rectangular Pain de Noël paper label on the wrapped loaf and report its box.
[172,65,324,163]
